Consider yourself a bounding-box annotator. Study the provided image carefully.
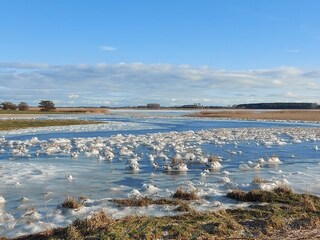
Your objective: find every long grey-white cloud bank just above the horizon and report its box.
[0,63,320,106]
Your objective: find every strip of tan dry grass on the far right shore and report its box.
[191,110,320,122]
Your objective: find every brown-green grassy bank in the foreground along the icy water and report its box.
[10,188,320,240]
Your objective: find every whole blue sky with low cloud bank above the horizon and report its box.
[0,0,320,107]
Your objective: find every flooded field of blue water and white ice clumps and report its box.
[0,111,320,237]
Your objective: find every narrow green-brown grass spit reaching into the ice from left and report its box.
[0,119,100,131]
